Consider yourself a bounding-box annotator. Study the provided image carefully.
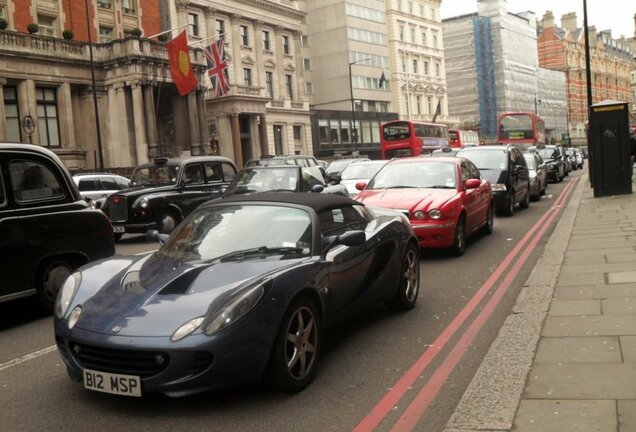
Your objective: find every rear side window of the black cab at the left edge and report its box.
[9,159,64,202]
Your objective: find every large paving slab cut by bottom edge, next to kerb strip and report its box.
[514,400,617,432]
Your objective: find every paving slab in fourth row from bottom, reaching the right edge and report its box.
[542,315,636,338]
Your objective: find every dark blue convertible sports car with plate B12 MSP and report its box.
[54,193,419,396]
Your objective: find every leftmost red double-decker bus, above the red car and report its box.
[380,120,449,159]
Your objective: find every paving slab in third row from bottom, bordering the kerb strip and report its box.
[534,336,623,364]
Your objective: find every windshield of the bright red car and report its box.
[367,160,457,189]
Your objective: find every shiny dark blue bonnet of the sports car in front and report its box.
[74,254,307,337]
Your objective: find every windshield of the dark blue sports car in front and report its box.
[157,204,312,262]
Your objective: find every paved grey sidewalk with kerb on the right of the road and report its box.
[445,173,636,432]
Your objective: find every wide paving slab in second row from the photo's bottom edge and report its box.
[524,363,636,400]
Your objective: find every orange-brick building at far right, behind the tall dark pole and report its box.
[537,11,635,145]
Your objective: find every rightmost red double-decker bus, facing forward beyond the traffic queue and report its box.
[497,112,545,149]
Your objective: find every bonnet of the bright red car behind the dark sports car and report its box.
[356,189,457,210]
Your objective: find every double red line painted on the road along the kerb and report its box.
[353,178,579,432]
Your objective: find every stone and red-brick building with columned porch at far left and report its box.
[0,0,209,170]
